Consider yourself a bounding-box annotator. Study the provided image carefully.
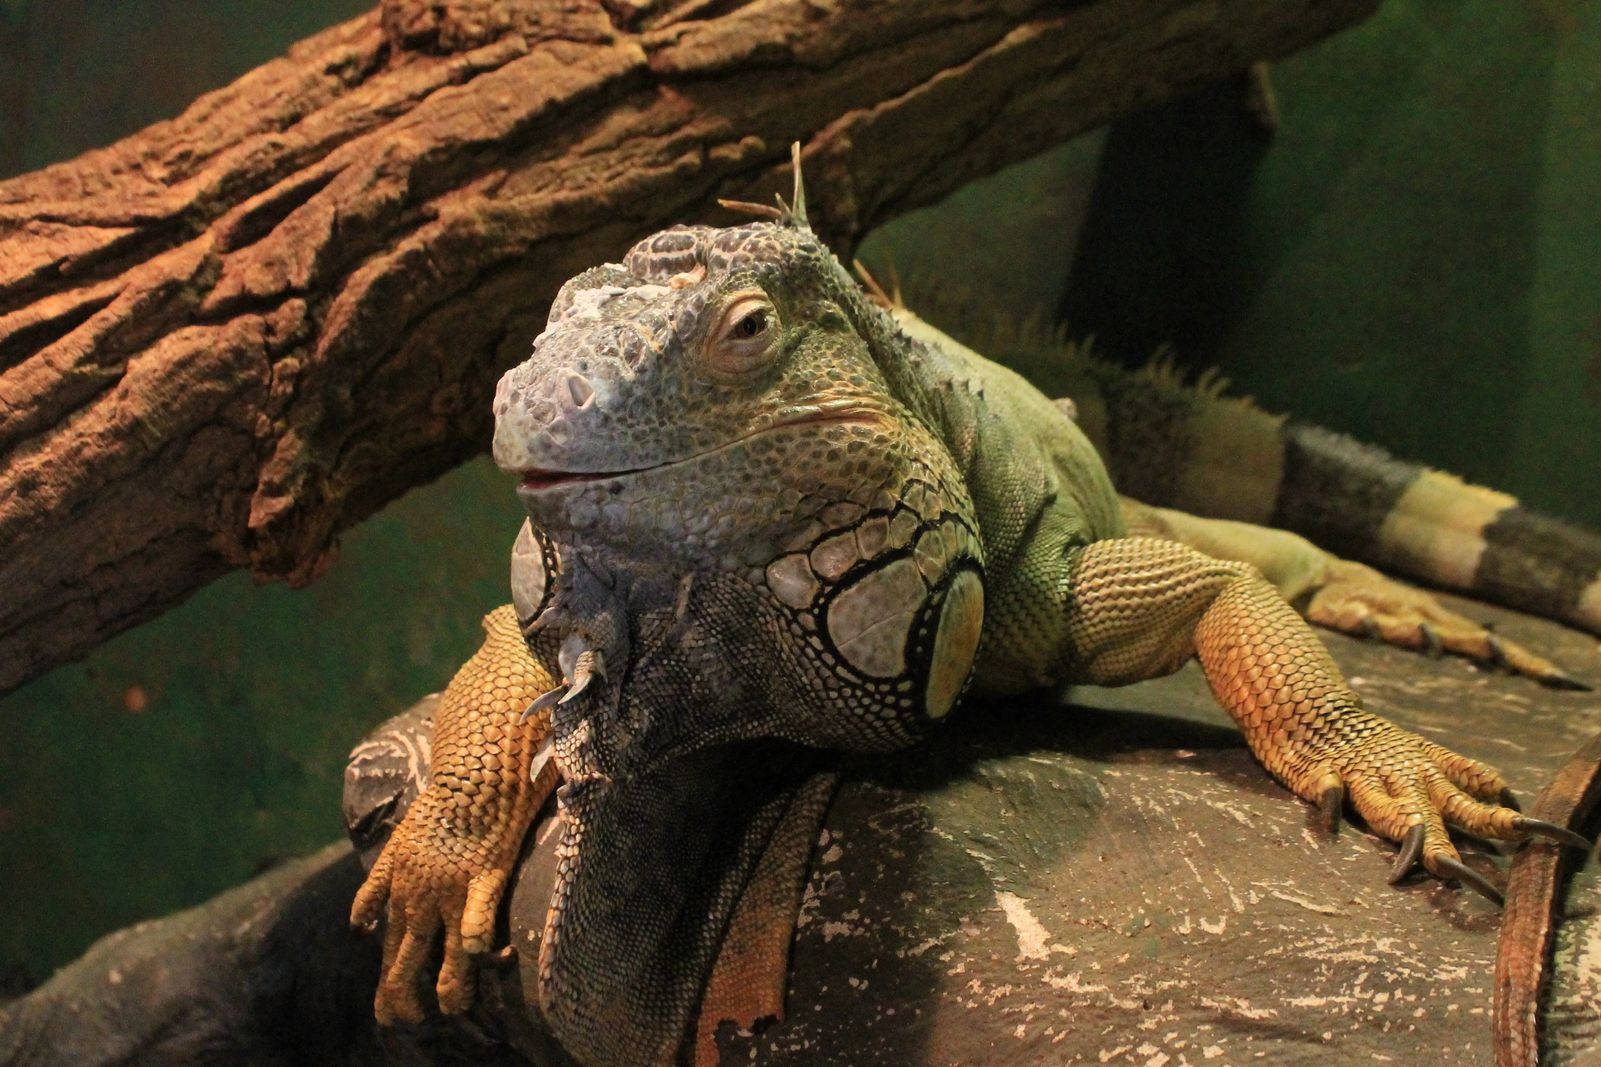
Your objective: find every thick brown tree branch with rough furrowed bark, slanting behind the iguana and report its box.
[0,0,1377,692]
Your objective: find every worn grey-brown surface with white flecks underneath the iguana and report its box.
[0,589,1601,1065]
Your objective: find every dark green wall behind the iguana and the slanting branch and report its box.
[0,0,1601,979]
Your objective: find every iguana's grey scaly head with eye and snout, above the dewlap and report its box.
[495,205,905,567]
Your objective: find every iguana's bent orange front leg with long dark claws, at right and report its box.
[1065,537,1588,899]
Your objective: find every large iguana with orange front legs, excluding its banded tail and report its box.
[352,151,1601,1064]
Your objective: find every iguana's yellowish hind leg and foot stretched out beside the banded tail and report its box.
[1119,497,1588,689]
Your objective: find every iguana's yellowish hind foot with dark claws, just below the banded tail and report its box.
[1306,559,1590,689]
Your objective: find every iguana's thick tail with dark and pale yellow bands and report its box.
[897,291,1601,634]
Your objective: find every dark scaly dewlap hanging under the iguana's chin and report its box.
[515,545,845,1064]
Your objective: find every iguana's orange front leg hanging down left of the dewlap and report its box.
[351,604,557,1025]
